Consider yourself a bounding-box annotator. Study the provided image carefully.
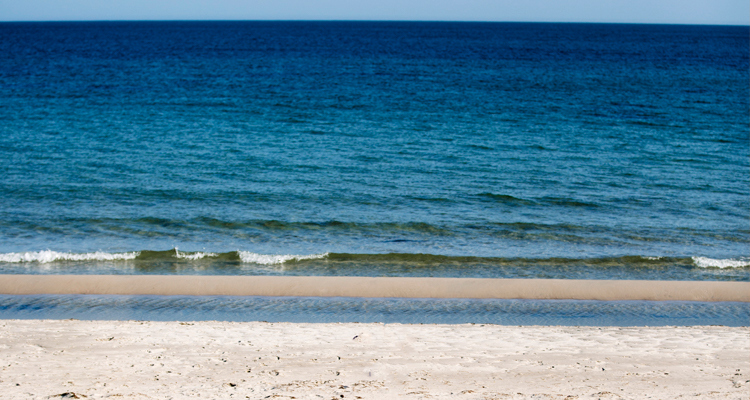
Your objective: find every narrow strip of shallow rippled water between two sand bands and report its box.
[0,295,750,326]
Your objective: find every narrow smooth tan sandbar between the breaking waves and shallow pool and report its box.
[0,275,750,302]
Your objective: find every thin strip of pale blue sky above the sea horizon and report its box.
[0,0,750,25]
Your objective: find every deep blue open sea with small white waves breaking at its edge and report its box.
[0,21,750,319]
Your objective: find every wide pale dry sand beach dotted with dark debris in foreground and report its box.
[0,320,750,399]
